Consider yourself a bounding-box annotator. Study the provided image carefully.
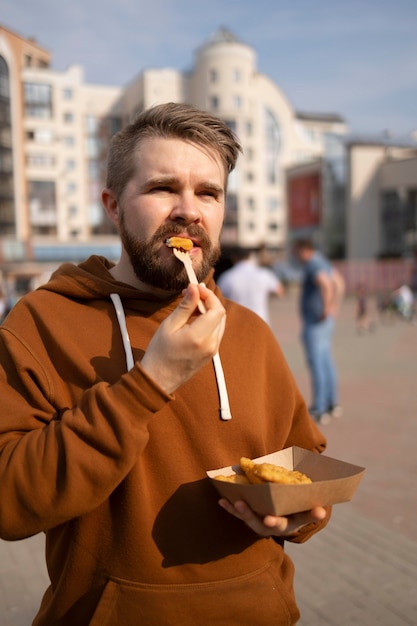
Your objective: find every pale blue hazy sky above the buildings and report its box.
[0,0,417,138]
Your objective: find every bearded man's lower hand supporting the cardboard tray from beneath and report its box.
[219,498,327,537]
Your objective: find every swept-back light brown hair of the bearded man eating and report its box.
[106,102,242,199]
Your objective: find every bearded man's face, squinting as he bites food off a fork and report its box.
[112,138,225,292]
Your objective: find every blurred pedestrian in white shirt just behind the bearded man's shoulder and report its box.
[217,245,284,324]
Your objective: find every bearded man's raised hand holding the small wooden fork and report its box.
[141,285,226,393]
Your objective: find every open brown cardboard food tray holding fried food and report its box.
[207,446,365,515]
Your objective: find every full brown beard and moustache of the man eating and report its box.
[119,213,220,292]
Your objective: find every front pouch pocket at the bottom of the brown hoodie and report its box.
[90,564,299,626]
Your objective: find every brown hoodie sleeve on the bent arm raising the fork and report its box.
[0,328,172,539]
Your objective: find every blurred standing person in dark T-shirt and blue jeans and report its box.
[294,239,344,425]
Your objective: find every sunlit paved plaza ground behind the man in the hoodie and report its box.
[0,292,417,626]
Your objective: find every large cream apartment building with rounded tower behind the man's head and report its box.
[0,26,347,274]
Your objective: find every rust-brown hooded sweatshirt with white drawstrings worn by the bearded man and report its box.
[0,257,327,626]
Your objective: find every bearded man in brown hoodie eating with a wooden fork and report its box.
[0,103,329,626]
